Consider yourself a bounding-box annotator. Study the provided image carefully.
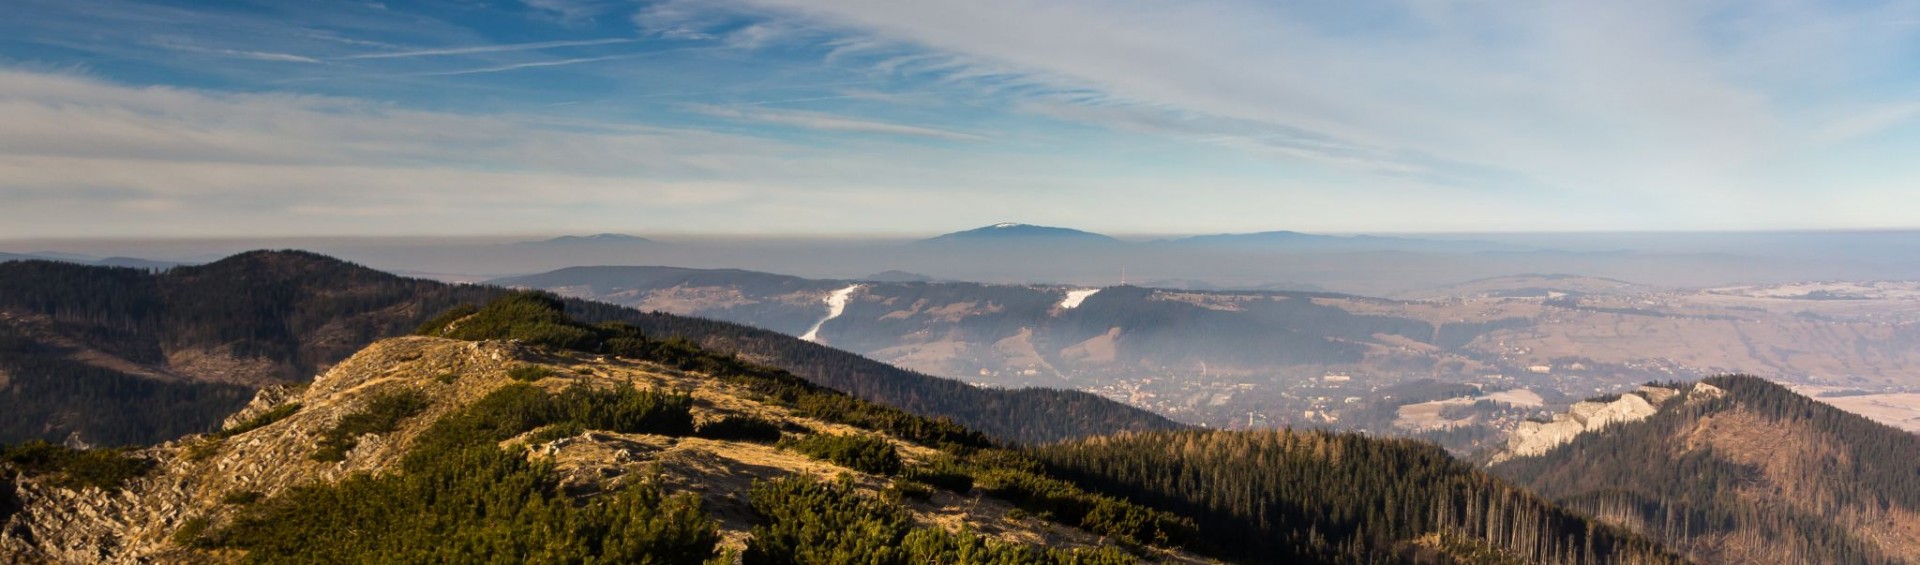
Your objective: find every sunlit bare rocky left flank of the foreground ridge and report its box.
[0,338,528,563]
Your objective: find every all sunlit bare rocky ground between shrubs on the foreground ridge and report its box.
[0,336,1200,565]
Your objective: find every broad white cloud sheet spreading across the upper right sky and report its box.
[645,0,1916,209]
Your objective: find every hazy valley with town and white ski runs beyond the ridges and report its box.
[495,267,1920,448]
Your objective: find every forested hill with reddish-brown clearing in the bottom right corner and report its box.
[1492,377,1920,563]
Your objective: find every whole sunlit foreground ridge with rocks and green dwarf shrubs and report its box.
[0,296,1206,565]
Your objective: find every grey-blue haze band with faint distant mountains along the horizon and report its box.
[0,224,1920,296]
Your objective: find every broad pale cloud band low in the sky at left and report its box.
[0,67,1136,238]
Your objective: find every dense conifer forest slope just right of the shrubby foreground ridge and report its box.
[1031,430,1684,563]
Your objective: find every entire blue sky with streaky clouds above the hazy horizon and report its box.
[0,0,1920,238]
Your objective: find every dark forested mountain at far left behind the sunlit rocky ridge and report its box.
[0,252,493,444]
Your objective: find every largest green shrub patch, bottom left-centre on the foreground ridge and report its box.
[211,384,718,563]
